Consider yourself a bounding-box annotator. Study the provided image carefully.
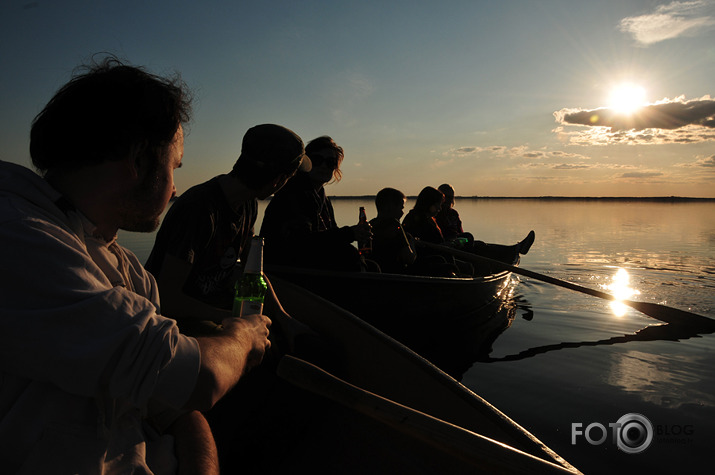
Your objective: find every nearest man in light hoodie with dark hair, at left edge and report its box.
[0,58,271,474]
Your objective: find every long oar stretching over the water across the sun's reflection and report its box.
[417,241,715,331]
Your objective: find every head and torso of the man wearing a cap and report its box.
[146,124,311,332]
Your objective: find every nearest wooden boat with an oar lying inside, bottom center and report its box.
[262,278,580,474]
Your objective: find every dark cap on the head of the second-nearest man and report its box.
[241,124,313,172]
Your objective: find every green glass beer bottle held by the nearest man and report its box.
[233,236,268,317]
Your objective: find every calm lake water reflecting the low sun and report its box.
[120,199,715,473]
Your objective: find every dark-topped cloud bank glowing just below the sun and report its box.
[554,96,715,145]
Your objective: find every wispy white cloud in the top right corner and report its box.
[619,0,715,46]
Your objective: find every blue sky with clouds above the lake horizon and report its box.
[0,0,715,197]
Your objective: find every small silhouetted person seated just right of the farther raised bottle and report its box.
[370,188,417,274]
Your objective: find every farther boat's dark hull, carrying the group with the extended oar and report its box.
[265,266,510,352]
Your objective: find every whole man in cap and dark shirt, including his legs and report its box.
[147,124,332,473]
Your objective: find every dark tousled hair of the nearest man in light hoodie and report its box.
[30,56,191,174]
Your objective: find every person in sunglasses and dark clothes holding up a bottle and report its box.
[261,136,372,271]
